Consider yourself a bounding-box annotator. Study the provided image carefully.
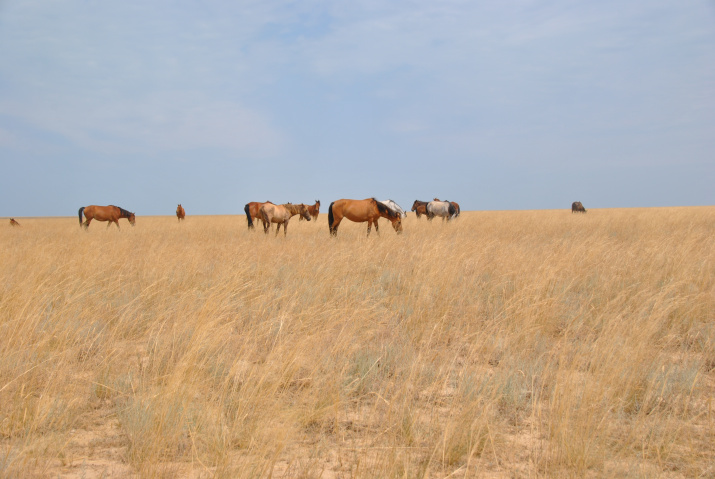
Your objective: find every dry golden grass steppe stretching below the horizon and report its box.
[0,207,715,478]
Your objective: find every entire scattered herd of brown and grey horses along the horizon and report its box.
[10,198,586,236]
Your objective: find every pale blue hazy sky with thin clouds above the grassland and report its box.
[0,0,715,217]
